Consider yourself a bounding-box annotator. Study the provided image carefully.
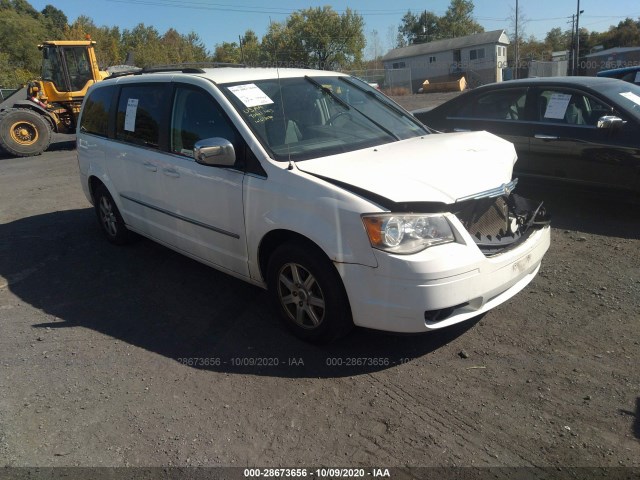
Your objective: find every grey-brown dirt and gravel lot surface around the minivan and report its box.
[0,95,640,478]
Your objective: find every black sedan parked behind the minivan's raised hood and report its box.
[413,77,640,193]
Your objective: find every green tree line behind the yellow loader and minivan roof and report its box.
[0,0,365,87]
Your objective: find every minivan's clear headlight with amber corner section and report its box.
[362,213,455,254]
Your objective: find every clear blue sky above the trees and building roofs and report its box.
[30,0,640,58]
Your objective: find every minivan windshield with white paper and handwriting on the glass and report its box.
[222,76,428,161]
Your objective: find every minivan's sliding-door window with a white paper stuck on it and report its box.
[116,83,168,148]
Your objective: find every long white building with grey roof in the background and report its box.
[382,30,509,92]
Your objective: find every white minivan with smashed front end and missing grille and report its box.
[77,67,550,342]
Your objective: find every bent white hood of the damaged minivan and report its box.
[296,132,517,203]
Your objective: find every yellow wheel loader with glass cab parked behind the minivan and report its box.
[0,40,109,157]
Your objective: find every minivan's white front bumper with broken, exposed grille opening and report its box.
[338,186,550,333]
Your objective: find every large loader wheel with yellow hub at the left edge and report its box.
[0,108,51,157]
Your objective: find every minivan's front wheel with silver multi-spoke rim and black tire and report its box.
[267,243,353,343]
